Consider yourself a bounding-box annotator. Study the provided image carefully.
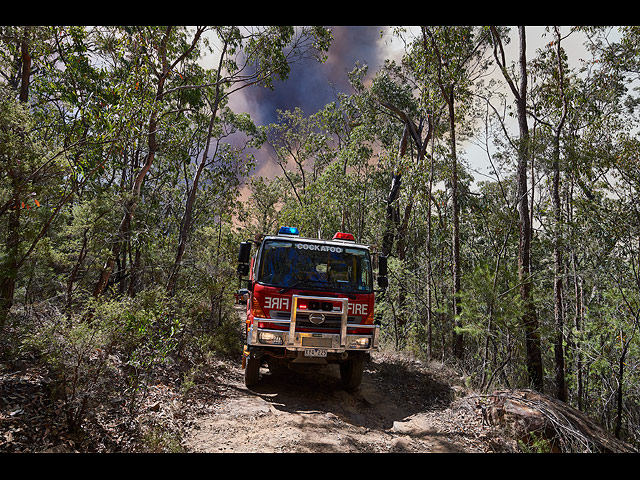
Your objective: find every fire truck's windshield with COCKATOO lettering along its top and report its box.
[258,240,372,293]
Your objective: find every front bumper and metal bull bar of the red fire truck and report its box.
[247,295,380,356]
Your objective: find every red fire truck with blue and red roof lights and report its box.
[238,227,387,389]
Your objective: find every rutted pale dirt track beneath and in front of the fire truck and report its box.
[183,306,500,453]
